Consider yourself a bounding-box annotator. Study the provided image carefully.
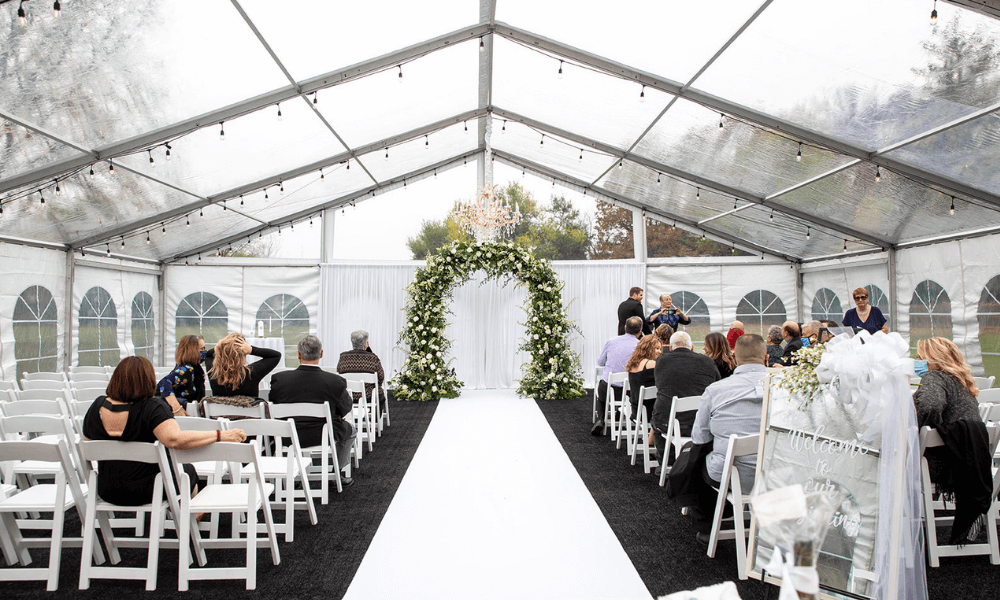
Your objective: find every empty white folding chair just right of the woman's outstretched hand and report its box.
[225,419,318,542]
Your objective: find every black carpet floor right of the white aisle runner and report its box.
[538,394,1000,600]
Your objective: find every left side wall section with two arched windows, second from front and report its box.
[67,266,162,367]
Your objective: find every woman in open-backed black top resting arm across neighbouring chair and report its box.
[83,356,247,506]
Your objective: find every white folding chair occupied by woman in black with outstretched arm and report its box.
[79,440,186,590]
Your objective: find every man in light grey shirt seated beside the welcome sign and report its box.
[691,333,767,544]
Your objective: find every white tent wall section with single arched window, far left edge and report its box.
[0,243,70,381]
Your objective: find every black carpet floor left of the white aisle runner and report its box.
[0,400,437,600]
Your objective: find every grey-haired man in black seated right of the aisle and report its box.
[652,331,719,465]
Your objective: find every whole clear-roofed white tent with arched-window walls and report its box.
[0,0,1000,387]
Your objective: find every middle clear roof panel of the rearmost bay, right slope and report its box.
[599,161,733,221]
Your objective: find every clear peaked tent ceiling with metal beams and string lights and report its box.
[0,0,1000,262]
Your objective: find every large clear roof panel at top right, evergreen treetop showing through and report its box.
[695,0,1000,150]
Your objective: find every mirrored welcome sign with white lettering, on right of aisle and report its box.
[748,378,879,598]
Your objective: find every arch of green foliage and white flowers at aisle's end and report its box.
[390,241,585,400]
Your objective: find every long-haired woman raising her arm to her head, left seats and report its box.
[205,333,281,398]
